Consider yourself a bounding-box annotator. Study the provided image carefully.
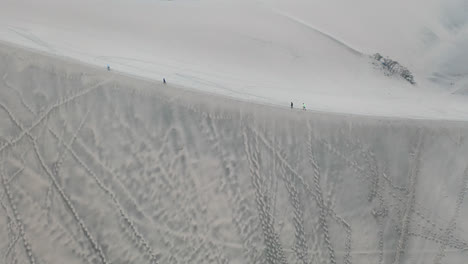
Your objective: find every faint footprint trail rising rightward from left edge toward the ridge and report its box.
[0,78,112,152]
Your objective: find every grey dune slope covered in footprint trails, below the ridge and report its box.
[0,46,468,264]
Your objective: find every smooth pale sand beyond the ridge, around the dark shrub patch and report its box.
[0,0,468,118]
